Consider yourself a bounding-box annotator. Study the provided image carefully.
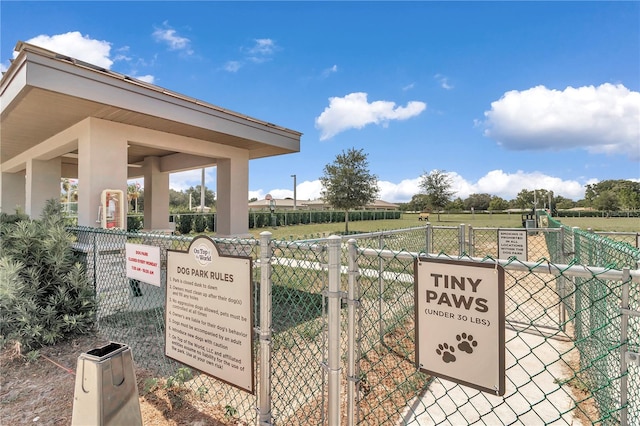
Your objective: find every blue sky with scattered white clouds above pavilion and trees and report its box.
[0,0,640,202]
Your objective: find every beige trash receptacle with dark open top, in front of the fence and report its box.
[71,342,142,426]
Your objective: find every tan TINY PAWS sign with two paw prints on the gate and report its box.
[414,258,505,395]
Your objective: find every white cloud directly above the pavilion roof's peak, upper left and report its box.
[13,31,113,69]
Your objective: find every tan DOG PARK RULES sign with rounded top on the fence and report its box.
[165,237,255,394]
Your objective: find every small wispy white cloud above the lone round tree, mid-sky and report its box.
[316,92,427,140]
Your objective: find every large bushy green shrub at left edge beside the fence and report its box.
[0,200,95,350]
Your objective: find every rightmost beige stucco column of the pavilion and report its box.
[216,152,249,237]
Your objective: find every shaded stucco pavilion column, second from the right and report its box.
[142,157,169,230]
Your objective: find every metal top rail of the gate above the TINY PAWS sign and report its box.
[350,240,640,283]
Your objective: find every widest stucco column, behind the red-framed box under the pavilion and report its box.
[78,118,127,227]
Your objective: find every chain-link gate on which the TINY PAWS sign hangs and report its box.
[347,243,640,425]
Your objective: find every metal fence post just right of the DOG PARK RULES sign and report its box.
[258,231,272,425]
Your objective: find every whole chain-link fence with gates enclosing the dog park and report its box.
[67,221,640,425]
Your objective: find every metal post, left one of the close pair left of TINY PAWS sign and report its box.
[327,235,342,426]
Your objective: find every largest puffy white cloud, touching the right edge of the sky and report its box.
[479,83,640,161]
